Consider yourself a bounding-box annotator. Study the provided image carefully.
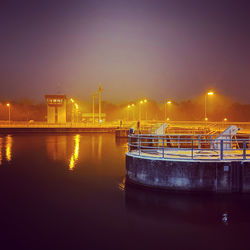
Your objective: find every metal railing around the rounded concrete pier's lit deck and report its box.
[128,134,250,161]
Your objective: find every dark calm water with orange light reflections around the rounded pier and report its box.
[0,134,250,250]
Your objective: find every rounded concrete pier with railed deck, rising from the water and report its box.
[126,129,250,193]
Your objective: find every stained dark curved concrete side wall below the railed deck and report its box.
[126,153,250,193]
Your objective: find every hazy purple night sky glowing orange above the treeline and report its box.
[0,0,250,103]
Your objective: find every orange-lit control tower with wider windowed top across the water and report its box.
[45,95,66,123]
